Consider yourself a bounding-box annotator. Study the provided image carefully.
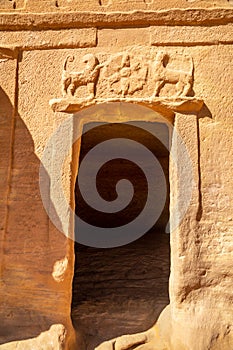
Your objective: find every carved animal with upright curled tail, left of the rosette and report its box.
[62,54,103,98]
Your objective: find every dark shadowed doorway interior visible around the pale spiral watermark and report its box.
[72,122,170,349]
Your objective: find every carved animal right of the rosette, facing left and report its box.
[152,52,193,97]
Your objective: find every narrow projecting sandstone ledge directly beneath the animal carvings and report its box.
[49,97,204,114]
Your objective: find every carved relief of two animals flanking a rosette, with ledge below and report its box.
[50,50,203,112]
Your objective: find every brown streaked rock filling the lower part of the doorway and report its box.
[72,231,170,349]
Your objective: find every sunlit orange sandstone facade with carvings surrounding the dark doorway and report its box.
[0,0,233,350]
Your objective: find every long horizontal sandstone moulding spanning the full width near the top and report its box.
[0,8,233,30]
